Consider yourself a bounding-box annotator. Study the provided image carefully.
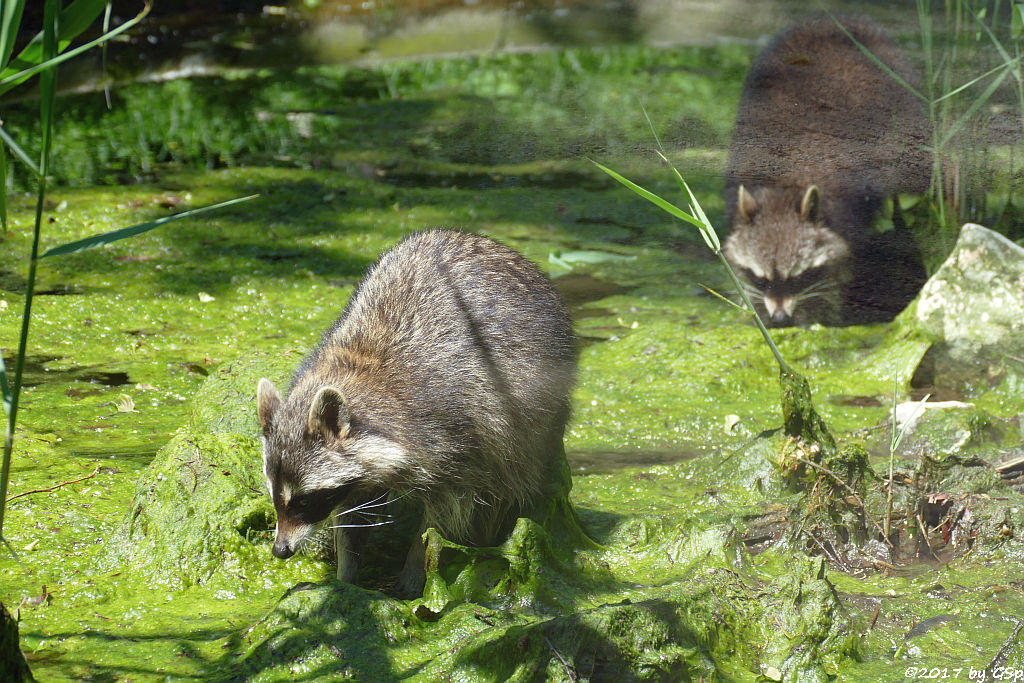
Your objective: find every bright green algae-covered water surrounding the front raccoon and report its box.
[0,24,1024,681]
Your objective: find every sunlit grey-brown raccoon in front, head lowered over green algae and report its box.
[257,229,575,594]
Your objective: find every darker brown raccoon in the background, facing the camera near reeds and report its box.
[724,17,932,327]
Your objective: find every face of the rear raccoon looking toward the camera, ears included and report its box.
[723,185,850,327]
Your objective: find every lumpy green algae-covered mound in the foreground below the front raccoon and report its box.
[225,520,858,681]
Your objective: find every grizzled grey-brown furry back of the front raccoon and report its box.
[323,230,575,452]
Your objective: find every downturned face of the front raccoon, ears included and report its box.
[256,379,357,559]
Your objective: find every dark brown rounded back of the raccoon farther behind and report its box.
[727,17,931,198]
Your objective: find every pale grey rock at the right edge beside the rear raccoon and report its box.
[916,223,1024,379]
